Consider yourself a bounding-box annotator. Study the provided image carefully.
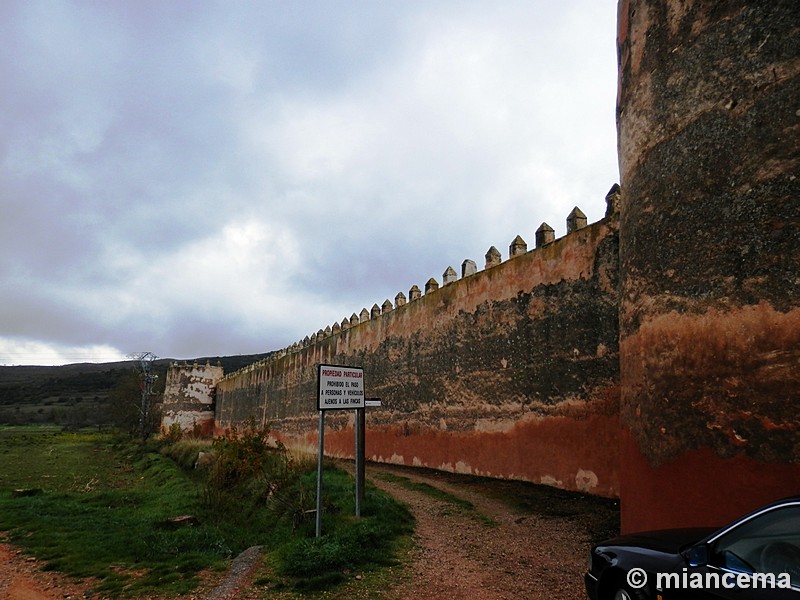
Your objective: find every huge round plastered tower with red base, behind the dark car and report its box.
[618,0,800,531]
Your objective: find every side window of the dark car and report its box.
[713,505,800,587]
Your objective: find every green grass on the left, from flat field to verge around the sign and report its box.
[0,427,412,596]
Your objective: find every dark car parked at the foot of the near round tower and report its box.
[584,496,800,600]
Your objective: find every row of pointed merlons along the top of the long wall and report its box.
[222,184,620,381]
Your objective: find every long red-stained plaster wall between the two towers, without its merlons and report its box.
[216,203,619,495]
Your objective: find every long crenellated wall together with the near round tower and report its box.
[161,0,800,532]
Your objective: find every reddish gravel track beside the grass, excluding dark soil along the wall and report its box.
[369,465,590,600]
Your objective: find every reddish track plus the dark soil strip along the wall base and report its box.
[369,465,618,600]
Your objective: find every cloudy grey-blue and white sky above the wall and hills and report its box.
[0,0,619,365]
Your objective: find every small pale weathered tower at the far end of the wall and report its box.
[161,363,223,434]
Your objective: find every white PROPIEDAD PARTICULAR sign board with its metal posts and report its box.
[317,365,364,537]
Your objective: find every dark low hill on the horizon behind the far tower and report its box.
[0,352,271,427]
